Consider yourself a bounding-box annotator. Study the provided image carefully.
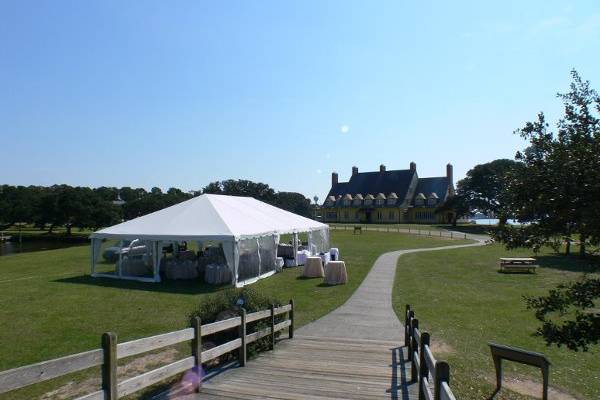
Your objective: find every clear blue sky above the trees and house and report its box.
[0,0,600,199]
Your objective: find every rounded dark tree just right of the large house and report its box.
[455,159,522,225]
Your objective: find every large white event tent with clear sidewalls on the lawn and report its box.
[90,194,329,285]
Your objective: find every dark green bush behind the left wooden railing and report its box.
[190,287,285,366]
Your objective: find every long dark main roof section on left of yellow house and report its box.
[327,169,416,199]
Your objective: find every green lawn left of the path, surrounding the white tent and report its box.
[0,231,472,399]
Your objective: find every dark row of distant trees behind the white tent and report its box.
[0,179,311,235]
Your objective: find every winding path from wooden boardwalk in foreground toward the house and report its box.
[192,233,484,400]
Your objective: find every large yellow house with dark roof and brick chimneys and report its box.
[321,162,454,224]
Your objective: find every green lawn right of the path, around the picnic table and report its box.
[393,245,600,399]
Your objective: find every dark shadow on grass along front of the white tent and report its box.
[54,275,231,295]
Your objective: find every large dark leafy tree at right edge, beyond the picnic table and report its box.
[497,71,600,256]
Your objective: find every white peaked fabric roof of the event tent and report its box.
[90,194,327,240]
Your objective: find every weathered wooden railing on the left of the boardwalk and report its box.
[0,300,294,400]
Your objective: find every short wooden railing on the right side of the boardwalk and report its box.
[404,304,456,400]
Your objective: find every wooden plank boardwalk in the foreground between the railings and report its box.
[192,336,417,400]
